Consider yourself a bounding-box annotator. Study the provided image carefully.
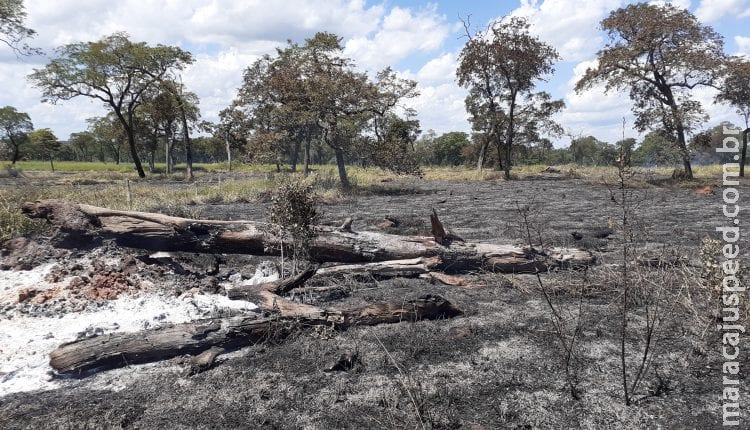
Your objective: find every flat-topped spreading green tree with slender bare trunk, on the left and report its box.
[29,33,193,178]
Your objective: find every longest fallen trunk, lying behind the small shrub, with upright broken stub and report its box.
[22,200,594,272]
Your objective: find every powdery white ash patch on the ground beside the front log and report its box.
[0,263,258,397]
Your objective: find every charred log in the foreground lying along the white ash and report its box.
[50,291,461,376]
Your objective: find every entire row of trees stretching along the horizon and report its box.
[0,1,750,180]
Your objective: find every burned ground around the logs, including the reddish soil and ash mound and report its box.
[0,175,750,429]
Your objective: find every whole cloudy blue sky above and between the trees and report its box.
[0,0,750,146]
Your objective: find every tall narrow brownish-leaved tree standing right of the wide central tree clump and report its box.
[456,17,564,178]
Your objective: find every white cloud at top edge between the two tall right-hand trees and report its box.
[511,0,621,61]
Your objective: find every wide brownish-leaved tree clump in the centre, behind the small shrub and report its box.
[232,32,417,187]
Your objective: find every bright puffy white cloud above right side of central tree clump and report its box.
[344,5,450,71]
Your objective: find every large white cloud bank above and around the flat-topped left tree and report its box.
[8,0,390,139]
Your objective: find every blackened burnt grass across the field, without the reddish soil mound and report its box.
[0,173,750,429]
